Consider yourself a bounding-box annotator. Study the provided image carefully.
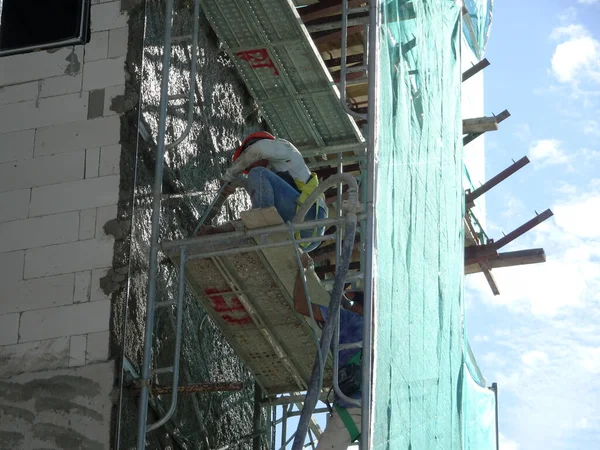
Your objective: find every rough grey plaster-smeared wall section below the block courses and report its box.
[0,362,114,450]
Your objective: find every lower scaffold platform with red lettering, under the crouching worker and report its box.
[163,207,333,395]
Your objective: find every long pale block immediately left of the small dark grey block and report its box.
[0,91,88,133]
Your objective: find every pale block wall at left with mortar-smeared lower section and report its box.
[0,0,128,449]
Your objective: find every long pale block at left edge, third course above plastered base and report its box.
[0,273,74,314]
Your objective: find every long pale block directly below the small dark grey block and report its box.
[35,117,121,157]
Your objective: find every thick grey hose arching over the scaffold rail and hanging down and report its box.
[292,174,360,450]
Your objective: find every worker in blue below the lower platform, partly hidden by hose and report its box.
[294,253,364,450]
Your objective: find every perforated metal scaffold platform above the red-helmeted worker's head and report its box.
[200,0,364,153]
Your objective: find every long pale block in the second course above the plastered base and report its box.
[19,300,110,342]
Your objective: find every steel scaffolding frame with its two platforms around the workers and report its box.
[137,0,379,450]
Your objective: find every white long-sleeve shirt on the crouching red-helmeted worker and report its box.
[223,139,310,182]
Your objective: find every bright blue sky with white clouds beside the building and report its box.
[466,0,600,450]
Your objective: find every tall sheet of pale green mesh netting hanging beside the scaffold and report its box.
[373,0,464,450]
